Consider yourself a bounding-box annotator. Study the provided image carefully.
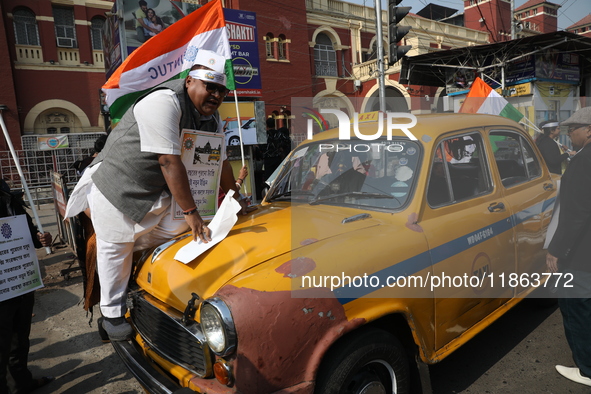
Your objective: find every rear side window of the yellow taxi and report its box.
[489,131,542,187]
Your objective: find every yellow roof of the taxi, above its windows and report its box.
[313,113,523,142]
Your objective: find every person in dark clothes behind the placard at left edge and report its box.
[0,179,54,394]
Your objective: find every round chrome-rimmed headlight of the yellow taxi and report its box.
[199,297,236,356]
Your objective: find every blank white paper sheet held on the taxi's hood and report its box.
[174,190,242,264]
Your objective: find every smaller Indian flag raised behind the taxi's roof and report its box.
[459,77,523,122]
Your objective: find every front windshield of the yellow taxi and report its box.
[266,139,421,209]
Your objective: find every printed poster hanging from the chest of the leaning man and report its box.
[172,129,225,220]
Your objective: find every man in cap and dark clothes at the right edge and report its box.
[546,107,591,386]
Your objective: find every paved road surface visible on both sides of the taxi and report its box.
[29,205,591,394]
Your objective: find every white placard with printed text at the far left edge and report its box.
[0,215,43,301]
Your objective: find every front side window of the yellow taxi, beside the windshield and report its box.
[427,133,492,207]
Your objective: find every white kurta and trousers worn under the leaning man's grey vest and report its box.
[66,89,226,317]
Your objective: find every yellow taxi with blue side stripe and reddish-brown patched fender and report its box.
[113,114,556,394]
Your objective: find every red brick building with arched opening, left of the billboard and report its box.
[0,0,112,150]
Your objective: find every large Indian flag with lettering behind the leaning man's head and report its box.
[103,0,235,123]
